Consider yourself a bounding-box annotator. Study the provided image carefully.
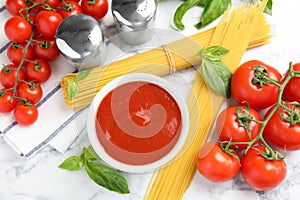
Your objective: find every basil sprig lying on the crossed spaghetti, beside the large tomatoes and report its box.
[198,46,232,98]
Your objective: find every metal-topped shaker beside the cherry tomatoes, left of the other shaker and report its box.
[56,14,105,71]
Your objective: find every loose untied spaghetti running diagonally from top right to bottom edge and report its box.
[144,1,266,200]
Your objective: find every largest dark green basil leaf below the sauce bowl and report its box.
[85,161,129,194]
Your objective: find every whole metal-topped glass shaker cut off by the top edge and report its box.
[111,0,157,45]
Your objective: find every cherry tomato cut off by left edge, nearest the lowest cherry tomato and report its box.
[0,89,18,113]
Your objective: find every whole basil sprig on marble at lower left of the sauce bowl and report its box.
[58,146,129,194]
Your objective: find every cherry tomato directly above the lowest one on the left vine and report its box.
[18,82,43,104]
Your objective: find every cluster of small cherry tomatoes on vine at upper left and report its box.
[0,0,108,125]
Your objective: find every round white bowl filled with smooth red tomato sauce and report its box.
[87,73,189,172]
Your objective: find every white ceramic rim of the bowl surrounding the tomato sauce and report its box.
[87,73,189,173]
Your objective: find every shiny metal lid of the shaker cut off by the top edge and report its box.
[112,0,157,29]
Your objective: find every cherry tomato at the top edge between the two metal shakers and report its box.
[81,0,108,20]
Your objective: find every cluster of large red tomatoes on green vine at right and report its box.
[197,60,300,190]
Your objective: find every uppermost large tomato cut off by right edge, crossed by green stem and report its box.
[282,63,300,103]
